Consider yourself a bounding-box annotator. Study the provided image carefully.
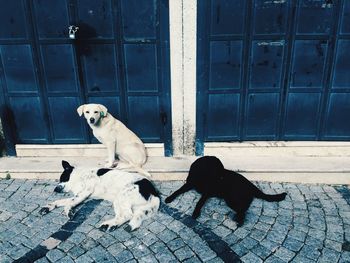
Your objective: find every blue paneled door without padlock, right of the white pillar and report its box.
[197,0,350,153]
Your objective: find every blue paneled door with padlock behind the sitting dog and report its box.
[0,0,171,156]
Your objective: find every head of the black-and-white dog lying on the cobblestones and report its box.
[54,161,91,194]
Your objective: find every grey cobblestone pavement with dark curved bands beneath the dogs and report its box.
[0,179,350,263]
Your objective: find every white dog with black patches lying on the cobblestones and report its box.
[40,161,160,231]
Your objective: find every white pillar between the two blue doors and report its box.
[169,0,197,156]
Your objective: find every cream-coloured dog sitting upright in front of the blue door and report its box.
[77,104,151,176]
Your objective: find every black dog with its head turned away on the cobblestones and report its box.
[165,156,287,226]
